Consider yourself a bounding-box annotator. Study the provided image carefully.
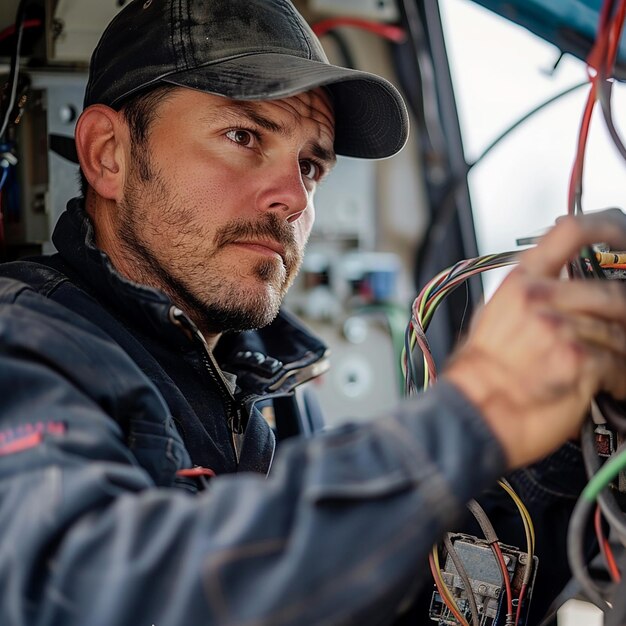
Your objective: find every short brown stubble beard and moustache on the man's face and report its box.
[119,166,302,333]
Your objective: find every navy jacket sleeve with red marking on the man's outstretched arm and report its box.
[0,288,504,626]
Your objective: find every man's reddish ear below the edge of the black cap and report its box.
[75,104,129,201]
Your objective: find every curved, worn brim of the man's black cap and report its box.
[159,53,409,159]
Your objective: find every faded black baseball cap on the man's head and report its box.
[84,0,409,158]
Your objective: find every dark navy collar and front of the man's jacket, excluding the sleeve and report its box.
[0,199,327,474]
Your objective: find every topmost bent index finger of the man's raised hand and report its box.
[519,209,626,277]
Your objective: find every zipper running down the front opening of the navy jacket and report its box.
[169,306,243,464]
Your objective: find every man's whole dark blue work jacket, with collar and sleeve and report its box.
[0,196,584,626]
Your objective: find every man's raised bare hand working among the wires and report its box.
[444,210,626,467]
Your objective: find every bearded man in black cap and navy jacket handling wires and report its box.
[0,0,626,626]
